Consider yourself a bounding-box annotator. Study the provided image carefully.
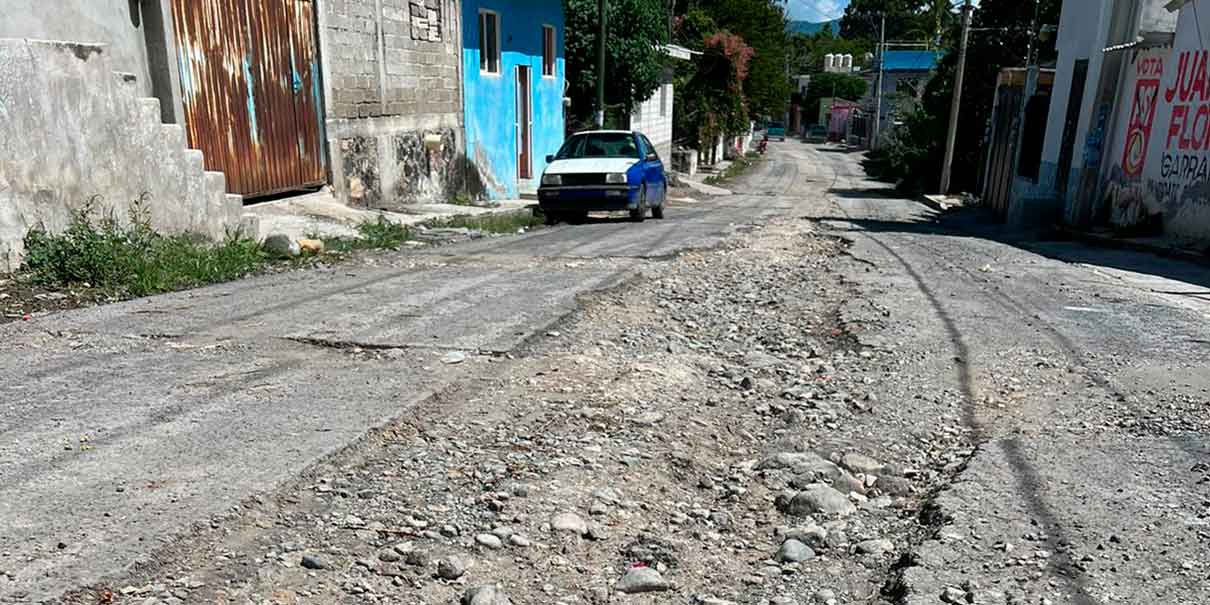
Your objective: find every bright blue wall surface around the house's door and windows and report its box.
[462,0,564,200]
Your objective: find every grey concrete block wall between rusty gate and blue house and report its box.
[318,0,466,208]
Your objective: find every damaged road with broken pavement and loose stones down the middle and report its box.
[0,143,1210,605]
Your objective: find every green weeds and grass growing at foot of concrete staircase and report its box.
[23,202,269,298]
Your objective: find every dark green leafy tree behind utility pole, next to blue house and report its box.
[563,0,668,127]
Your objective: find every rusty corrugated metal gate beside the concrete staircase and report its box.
[172,0,327,197]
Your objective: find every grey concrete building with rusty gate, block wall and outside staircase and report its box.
[0,0,474,265]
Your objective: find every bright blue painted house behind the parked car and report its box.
[462,0,564,200]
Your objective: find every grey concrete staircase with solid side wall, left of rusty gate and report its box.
[0,39,243,270]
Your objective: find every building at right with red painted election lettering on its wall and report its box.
[1008,0,1190,235]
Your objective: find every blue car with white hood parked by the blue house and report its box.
[537,131,668,225]
